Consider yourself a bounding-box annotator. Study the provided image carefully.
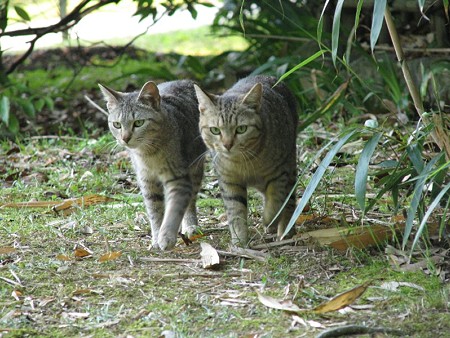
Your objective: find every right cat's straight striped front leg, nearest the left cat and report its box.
[220,180,249,247]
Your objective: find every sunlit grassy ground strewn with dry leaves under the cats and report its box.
[0,135,450,337]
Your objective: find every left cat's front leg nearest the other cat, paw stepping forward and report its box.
[158,175,192,250]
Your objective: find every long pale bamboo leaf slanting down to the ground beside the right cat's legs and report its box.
[281,130,356,239]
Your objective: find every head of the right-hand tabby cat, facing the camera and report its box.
[194,83,263,157]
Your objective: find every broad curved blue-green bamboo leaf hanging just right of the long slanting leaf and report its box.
[355,133,382,212]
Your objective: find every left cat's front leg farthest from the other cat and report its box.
[140,179,164,248]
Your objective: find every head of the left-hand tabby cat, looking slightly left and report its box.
[99,82,163,149]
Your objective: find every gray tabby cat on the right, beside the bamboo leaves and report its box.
[195,76,298,246]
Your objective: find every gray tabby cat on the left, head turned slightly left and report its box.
[99,80,206,250]
